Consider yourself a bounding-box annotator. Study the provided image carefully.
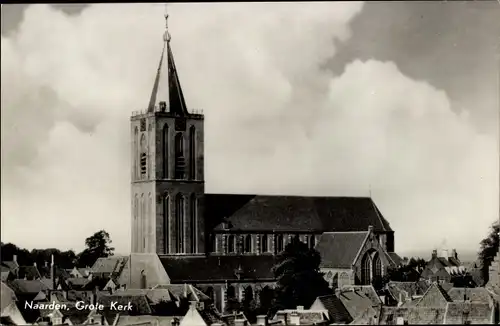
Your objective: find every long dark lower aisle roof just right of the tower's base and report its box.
[159,255,275,283]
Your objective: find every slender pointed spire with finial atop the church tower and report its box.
[148,4,188,116]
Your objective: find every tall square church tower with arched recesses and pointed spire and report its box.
[131,11,205,255]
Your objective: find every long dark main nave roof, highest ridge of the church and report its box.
[209,194,392,232]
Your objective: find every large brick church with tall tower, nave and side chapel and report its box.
[94,14,400,311]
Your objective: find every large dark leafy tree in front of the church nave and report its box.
[272,237,332,312]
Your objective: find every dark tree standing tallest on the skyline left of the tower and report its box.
[77,230,115,267]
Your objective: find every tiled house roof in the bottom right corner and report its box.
[444,302,494,325]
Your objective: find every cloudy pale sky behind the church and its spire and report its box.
[1,1,500,256]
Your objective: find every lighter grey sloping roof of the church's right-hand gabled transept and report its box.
[315,231,368,268]
